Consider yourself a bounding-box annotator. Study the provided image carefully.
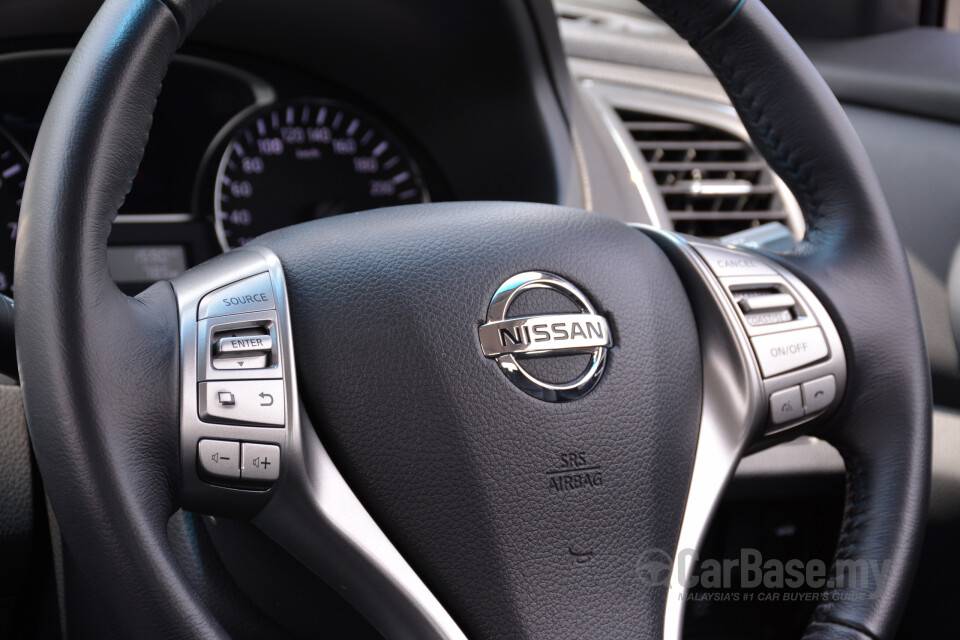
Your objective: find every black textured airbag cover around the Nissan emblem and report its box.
[257,203,701,638]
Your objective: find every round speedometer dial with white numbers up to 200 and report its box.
[214,99,429,250]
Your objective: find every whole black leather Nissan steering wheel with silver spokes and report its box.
[16,0,931,639]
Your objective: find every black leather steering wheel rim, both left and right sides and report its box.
[16,0,931,638]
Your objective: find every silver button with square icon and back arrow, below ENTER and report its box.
[199,380,284,427]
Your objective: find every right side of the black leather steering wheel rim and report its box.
[636,0,931,638]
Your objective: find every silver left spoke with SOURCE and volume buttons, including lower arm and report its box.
[172,246,465,640]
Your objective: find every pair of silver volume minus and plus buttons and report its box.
[197,438,280,482]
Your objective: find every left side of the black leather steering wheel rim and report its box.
[16,0,221,638]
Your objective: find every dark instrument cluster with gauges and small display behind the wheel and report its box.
[0,49,452,294]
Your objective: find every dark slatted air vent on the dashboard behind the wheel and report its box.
[617,109,788,238]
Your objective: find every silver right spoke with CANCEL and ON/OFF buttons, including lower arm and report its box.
[637,225,847,640]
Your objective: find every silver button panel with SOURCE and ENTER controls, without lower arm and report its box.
[172,248,292,500]
